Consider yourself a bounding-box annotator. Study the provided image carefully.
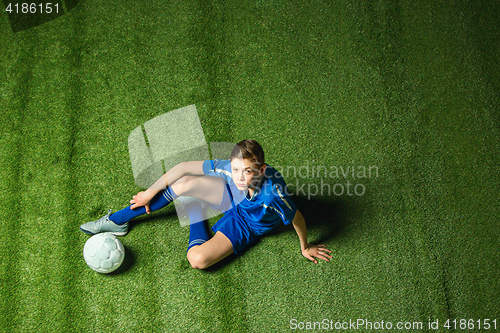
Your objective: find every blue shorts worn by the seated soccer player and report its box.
[211,184,259,254]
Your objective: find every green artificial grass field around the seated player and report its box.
[0,0,500,332]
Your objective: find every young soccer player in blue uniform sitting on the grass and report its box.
[80,140,332,269]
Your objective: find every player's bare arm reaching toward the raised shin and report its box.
[130,161,204,213]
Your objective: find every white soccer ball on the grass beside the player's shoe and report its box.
[83,232,125,274]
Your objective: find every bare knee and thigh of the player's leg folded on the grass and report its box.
[187,231,233,269]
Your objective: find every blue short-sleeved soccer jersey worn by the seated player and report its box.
[203,160,297,236]
